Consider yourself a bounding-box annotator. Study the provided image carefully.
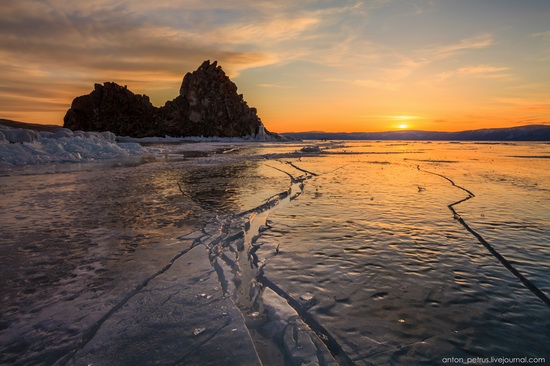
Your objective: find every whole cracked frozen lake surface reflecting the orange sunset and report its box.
[0,141,550,365]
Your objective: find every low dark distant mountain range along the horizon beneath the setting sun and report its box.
[282,125,550,141]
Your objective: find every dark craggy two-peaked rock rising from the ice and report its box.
[63,61,269,137]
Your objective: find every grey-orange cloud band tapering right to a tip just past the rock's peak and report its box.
[0,1,280,77]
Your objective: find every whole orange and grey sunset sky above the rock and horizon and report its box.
[0,0,550,132]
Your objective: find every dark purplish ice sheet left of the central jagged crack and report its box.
[0,147,298,364]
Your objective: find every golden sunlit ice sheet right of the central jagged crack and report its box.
[257,142,550,365]
